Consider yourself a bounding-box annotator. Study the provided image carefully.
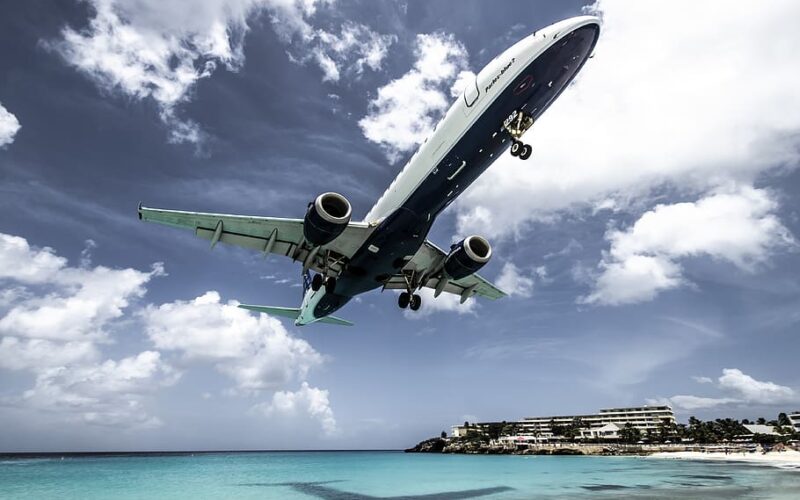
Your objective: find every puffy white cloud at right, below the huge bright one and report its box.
[581,187,794,305]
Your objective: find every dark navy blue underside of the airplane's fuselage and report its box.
[336,20,599,304]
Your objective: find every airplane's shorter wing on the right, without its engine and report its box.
[385,240,508,303]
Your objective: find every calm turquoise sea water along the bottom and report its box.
[0,452,800,500]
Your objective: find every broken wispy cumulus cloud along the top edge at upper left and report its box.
[51,0,394,143]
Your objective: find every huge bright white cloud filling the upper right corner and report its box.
[456,0,800,237]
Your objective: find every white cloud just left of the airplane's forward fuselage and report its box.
[358,33,468,162]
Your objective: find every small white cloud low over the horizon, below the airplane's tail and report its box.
[252,382,338,436]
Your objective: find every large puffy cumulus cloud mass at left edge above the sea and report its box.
[0,234,169,427]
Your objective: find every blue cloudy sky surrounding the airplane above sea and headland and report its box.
[0,0,800,451]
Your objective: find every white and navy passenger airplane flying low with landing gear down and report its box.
[138,16,601,326]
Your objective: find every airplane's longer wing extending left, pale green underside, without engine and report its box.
[139,205,372,272]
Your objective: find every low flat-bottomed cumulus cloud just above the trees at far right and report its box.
[651,368,800,411]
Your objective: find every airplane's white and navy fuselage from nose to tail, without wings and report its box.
[295,16,600,325]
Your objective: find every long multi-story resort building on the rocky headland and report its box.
[452,405,676,442]
